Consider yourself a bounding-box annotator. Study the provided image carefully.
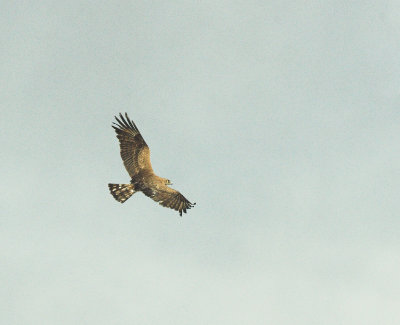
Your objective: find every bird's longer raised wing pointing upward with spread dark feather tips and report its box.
[112,113,153,177]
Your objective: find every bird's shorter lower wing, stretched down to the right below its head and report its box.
[143,186,196,216]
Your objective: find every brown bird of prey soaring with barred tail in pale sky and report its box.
[108,113,196,216]
